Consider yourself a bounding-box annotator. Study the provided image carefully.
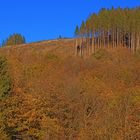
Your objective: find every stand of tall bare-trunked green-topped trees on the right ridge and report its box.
[75,7,140,52]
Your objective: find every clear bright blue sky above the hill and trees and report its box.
[0,0,140,42]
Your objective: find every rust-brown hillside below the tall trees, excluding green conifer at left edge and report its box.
[0,39,140,140]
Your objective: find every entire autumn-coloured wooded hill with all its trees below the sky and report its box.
[0,7,140,140]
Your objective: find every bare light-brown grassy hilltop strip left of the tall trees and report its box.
[1,39,75,53]
